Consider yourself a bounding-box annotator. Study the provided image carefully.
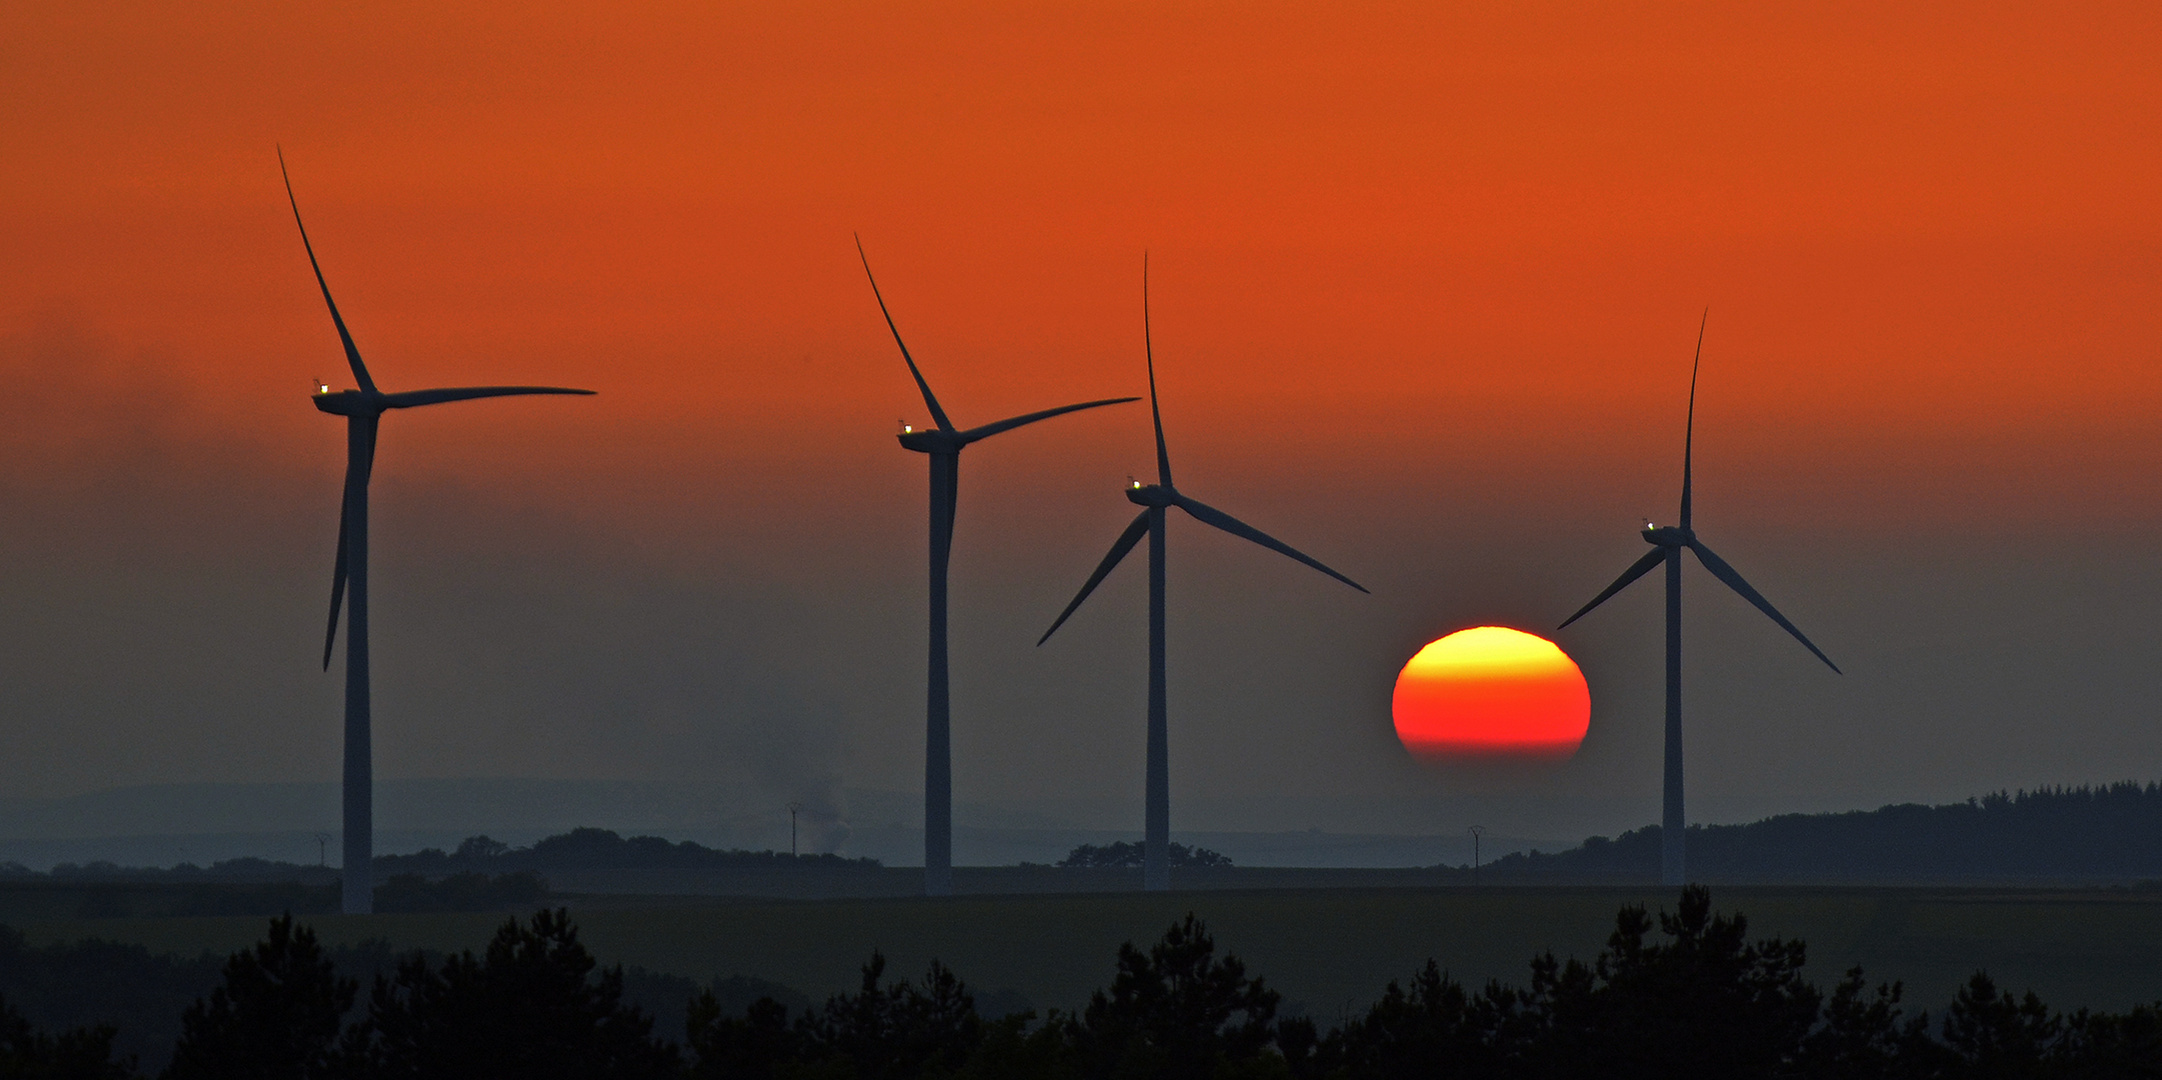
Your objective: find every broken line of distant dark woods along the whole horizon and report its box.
[25,782,2162,889]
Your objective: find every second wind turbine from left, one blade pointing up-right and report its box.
[856,235,1139,896]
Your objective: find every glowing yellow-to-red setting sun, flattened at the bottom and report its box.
[1390,626,1591,765]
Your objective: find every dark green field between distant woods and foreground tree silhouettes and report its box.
[0,870,2162,1020]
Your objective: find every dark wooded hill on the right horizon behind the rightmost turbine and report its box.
[1485,782,2162,883]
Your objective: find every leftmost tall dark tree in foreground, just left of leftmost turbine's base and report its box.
[162,914,359,1080]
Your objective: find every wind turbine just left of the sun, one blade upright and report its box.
[1036,257,1366,892]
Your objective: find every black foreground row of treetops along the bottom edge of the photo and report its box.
[0,888,2162,1080]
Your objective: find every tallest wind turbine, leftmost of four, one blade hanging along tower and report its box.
[277,151,592,916]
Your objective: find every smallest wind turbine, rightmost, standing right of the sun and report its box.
[1561,309,1844,886]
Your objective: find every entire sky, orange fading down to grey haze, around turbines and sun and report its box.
[0,2,2162,838]
